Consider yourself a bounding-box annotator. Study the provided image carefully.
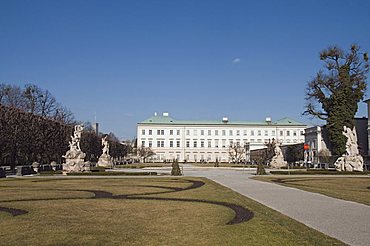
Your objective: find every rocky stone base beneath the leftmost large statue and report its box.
[63,150,90,174]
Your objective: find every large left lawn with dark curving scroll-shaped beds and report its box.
[0,177,343,245]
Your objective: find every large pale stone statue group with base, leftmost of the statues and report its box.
[63,125,90,174]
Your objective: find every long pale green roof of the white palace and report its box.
[138,115,306,126]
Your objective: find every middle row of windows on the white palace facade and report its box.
[141,139,303,148]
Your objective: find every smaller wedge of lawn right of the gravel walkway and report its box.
[255,175,370,206]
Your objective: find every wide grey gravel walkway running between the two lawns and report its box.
[180,165,370,245]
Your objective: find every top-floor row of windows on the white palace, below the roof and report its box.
[141,129,304,137]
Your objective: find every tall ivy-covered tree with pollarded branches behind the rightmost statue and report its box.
[304,44,369,155]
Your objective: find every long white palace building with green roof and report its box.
[137,113,307,162]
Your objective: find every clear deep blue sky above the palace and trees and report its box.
[0,0,370,139]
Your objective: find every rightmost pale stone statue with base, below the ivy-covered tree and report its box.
[334,126,364,172]
